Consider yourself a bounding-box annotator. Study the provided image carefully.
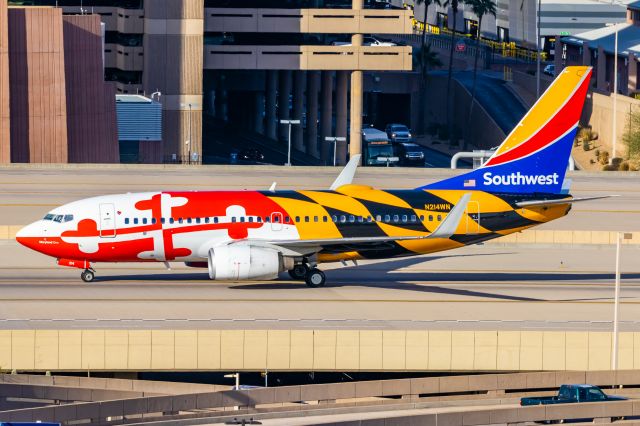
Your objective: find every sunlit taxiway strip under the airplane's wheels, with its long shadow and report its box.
[0,242,640,331]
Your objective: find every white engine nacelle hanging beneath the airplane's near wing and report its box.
[208,244,284,280]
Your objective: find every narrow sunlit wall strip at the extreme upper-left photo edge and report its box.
[0,0,11,164]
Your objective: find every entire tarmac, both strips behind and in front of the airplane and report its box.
[0,166,640,331]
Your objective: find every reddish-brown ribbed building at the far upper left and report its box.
[0,0,118,163]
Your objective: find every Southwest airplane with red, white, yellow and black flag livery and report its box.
[16,66,603,287]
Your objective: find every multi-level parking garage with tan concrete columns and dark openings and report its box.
[13,0,412,163]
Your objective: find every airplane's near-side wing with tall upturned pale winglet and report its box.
[242,193,471,251]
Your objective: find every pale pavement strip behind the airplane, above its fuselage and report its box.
[0,165,640,230]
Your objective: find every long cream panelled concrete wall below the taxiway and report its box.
[0,330,640,371]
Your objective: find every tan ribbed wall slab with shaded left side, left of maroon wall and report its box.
[9,8,68,163]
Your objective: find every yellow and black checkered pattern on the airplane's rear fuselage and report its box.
[262,185,570,262]
